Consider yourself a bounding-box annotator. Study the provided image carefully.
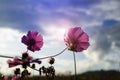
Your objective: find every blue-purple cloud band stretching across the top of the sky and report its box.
[0,0,118,32]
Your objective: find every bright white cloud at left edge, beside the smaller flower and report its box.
[0,28,22,75]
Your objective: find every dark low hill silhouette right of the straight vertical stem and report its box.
[78,70,120,80]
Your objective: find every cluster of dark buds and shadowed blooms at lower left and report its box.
[3,56,55,80]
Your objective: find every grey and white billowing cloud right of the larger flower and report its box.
[85,24,120,70]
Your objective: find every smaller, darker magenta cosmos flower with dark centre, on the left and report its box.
[21,31,43,52]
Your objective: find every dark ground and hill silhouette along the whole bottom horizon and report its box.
[0,70,120,80]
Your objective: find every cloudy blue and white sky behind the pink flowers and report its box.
[0,0,120,75]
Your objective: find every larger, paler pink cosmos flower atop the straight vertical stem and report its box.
[64,27,90,52]
